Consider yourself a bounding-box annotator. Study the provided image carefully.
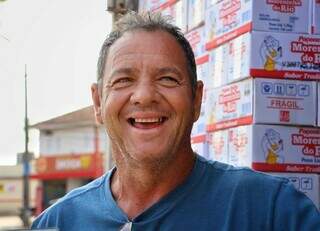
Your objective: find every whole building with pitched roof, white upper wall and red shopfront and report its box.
[31,107,112,212]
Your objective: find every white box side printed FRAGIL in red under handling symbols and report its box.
[253,79,317,126]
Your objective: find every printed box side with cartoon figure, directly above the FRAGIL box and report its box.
[250,32,320,80]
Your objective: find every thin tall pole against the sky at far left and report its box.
[22,64,30,228]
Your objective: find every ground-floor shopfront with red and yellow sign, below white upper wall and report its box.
[32,153,103,208]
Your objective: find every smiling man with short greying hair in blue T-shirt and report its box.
[33,13,320,231]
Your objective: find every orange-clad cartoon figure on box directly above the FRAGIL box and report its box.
[260,35,282,71]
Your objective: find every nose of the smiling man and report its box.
[130,81,159,106]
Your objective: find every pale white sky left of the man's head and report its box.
[0,0,112,165]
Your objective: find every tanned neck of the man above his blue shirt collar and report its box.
[111,148,195,219]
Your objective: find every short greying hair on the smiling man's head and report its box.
[97,11,197,97]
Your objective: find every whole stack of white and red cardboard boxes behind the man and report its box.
[140,0,320,208]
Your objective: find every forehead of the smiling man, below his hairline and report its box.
[106,30,186,70]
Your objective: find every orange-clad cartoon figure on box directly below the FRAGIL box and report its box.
[261,129,284,164]
